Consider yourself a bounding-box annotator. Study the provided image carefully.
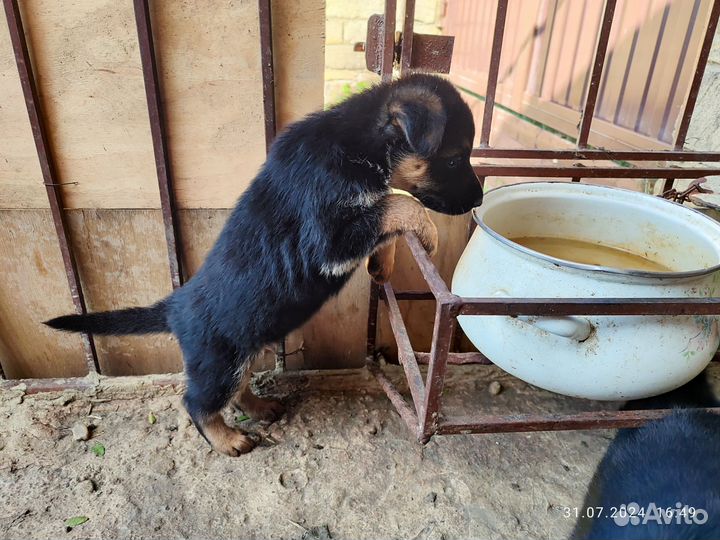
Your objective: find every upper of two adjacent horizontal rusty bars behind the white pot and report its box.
[471,148,720,161]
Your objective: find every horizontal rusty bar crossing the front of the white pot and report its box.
[458,297,720,317]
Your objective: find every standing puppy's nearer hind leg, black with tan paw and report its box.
[183,343,255,456]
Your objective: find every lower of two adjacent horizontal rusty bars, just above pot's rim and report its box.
[473,164,720,178]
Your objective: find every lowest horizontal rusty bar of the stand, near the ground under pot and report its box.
[435,407,720,435]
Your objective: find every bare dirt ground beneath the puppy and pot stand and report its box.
[0,366,648,539]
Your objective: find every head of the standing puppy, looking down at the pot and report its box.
[381,75,482,214]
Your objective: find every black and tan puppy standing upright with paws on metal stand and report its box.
[46,75,482,455]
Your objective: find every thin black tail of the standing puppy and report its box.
[44,300,170,336]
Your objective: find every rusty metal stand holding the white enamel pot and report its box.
[368,233,720,442]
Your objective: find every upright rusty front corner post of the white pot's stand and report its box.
[420,302,458,441]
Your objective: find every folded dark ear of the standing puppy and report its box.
[387,86,447,157]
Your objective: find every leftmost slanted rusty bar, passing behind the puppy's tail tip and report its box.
[3,0,100,373]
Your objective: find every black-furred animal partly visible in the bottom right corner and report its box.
[573,372,720,540]
